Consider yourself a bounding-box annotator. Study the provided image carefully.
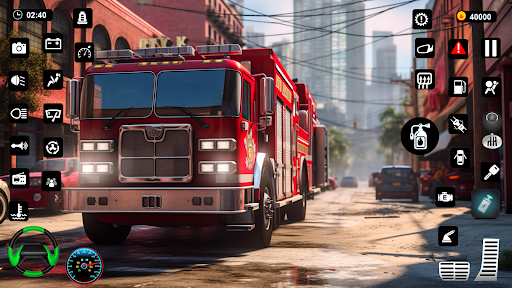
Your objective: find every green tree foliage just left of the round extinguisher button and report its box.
[379,106,407,156]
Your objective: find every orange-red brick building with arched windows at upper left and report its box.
[0,0,164,175]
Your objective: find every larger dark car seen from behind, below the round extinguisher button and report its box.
[375,166,419,203]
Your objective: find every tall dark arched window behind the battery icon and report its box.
[52,9,73,78]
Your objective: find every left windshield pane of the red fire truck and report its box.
[80,72,155,119]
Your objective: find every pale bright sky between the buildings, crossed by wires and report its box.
[244,0,427,77]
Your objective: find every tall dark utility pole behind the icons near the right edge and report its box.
[469,0,493,189]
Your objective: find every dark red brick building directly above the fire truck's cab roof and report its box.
[119,0,244,47]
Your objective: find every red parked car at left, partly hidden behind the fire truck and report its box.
[0,157,78,213]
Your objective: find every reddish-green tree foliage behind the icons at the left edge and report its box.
[0,30,52,120]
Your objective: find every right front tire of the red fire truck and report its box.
[247,167,279,248]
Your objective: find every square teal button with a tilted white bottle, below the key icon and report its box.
[471,189,501,219]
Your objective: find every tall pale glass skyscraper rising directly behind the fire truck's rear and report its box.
[293,0,347,123]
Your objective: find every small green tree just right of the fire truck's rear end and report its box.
[328,127,349,176]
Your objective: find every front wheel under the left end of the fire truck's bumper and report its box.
[82,213,132,244]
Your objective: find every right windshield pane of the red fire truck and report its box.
[156,70,242,116]
